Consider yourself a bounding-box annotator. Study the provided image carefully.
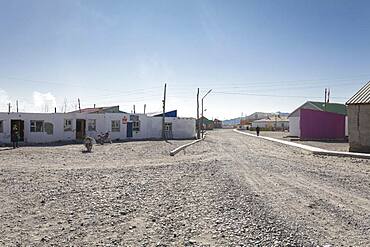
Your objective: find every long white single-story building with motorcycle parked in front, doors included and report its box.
[0,105,196,143]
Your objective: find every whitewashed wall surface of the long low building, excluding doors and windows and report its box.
[0,113,196,143]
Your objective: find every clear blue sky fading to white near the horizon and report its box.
[0,0,370,119]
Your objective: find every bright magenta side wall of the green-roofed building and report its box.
[300,109,346,140]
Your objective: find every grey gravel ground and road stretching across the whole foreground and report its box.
[0,130,370,246]
